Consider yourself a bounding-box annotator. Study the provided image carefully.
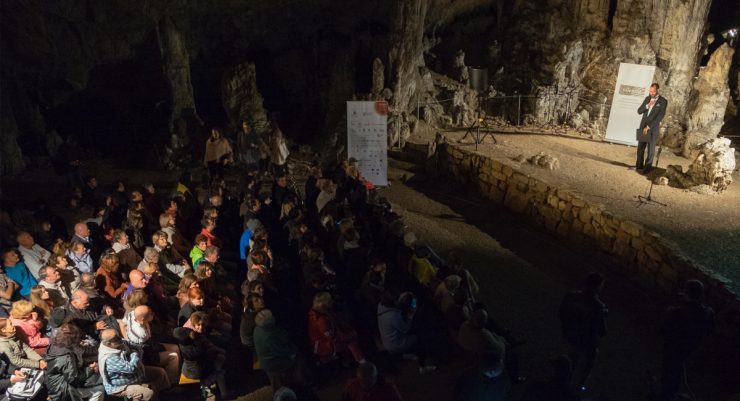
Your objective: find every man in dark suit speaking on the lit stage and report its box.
[636,84,668,174]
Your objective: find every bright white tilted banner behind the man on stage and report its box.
[605,63,655,145]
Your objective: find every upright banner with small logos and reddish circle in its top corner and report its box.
[347,102,388,186]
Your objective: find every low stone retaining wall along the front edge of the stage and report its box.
[438,144,740,316]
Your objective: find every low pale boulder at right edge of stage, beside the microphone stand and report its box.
[666,138,735,192]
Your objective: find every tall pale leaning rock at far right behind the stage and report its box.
[683,44,735,158]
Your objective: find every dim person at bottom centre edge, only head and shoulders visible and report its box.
[342,362,403,401]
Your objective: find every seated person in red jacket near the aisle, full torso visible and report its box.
[308,291,365,363]
